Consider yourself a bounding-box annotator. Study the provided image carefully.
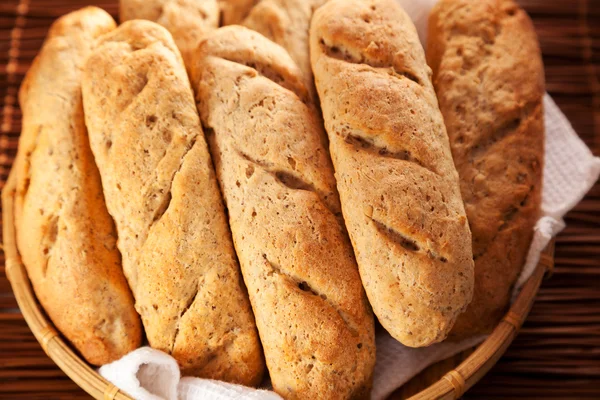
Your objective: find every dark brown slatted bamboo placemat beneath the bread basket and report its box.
[0,0,600,400]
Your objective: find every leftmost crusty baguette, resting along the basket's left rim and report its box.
[14,7,142,365]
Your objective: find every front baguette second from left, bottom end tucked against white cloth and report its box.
[83,20,263,385]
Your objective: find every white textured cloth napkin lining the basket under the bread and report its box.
[100,0,600,400]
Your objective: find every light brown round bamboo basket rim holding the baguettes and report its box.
[2,161,554,400]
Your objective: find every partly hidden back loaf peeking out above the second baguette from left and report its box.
[119,0,219,66]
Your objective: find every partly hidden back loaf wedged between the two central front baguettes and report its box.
[243,0,327,103]
